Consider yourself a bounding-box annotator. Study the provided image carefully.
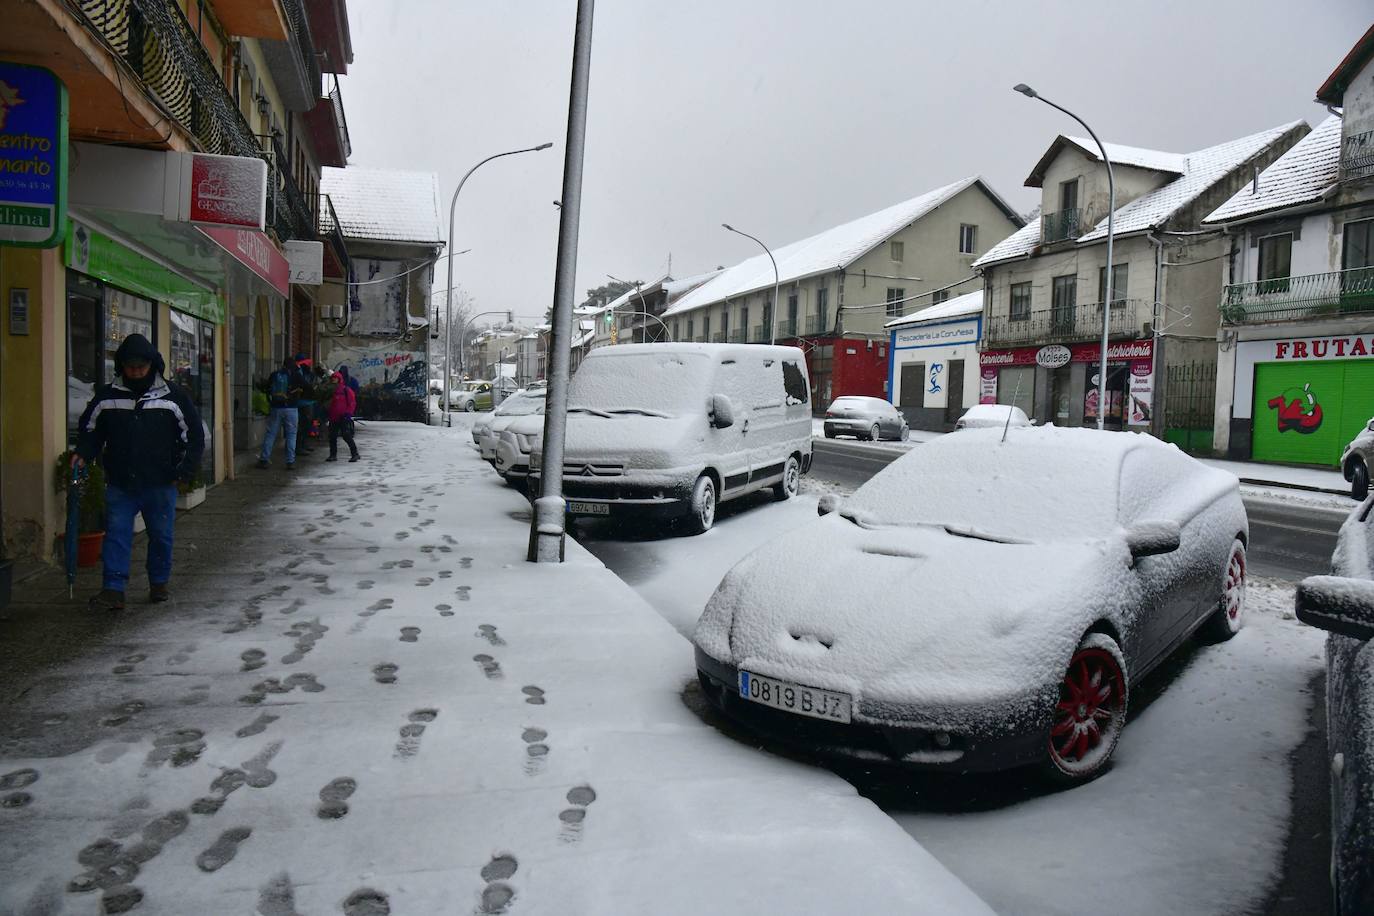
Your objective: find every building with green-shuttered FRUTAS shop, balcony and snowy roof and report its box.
[1208,29,1374,467]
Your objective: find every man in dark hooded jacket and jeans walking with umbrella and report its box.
[73,334,205,611]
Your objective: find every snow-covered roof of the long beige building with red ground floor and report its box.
[664,176,1020,317]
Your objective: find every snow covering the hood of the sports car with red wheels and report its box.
[694,515,1134,706]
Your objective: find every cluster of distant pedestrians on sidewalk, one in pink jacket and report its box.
[257,353,361,471]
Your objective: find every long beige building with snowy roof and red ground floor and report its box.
[662,177,1024,412]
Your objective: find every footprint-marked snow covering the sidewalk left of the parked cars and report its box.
[0,417,991,916]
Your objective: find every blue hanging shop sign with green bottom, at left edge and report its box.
[0,60,67,249]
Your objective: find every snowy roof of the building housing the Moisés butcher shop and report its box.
[973,121,1307,268]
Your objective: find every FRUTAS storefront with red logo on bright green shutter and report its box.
[1223,334,1374,467]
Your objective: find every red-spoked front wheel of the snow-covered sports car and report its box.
[1050,636,1127,777]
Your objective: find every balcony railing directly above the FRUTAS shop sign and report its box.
[1221,268,1374,324]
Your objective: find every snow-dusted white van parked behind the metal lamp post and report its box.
[529,343,811,531]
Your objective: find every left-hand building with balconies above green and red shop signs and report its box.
[0,0,353,559]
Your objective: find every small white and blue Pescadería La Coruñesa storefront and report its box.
[888,300,982,431]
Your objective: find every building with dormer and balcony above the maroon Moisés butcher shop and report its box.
[977,122,1308,439]
